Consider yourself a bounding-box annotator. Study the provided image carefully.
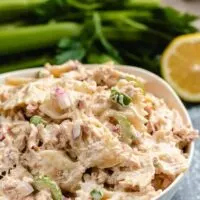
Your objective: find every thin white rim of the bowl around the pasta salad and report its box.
[0,64,195,200]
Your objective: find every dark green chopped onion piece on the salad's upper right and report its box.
[110,88,131,106]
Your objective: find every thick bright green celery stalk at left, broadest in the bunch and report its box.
[0,22,81,55]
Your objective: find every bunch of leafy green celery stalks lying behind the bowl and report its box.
[0,0,197,74]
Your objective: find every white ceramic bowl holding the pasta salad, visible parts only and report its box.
[0,65,194,200]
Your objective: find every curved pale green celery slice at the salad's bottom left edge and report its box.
[33,176,62,200]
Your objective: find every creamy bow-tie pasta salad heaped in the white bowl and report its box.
[0,61,197,200]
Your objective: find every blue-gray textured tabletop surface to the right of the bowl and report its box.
[173,105,200,200]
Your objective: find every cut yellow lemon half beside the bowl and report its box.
[161,33,200,102]
